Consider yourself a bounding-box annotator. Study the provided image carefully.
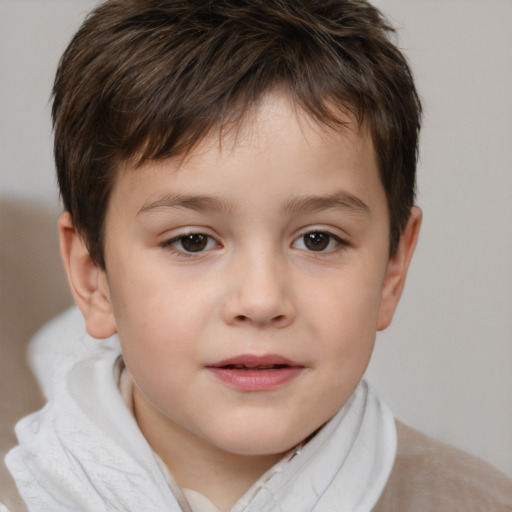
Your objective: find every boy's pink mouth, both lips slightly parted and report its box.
[206,354,305,392]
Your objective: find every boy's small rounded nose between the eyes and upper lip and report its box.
[222,248,296,328]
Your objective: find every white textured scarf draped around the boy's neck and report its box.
[6,311,396,512]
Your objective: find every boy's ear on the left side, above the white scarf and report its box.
[59,212,117,338]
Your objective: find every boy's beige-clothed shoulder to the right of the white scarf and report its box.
[374,422,512,512]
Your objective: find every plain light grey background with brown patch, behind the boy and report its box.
[0,0,512,476]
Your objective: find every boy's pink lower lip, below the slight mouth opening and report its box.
[207,366,304,391]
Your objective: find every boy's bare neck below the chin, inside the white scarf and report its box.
[133,387,283,510]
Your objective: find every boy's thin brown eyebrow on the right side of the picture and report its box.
[284,191,371,216]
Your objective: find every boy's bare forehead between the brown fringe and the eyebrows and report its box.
[111,93,380,216]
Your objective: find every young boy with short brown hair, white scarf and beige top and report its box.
[5,0,511,511]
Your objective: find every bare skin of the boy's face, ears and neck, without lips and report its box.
[59,93,421,509]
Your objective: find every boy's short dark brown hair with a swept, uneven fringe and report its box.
[52,0,421,268]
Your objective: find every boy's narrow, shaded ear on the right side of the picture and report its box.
[377,206,422,331]
